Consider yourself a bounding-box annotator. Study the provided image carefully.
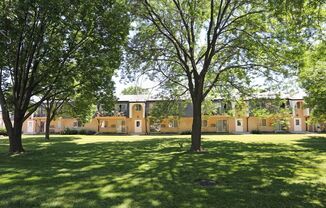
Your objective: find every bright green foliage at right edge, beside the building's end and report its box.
[299,41,326,123]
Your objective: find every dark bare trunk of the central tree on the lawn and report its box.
[190,99,202,152]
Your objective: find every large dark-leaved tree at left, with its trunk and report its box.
[0,0,128,152]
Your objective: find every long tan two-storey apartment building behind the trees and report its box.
[23,95,320,134]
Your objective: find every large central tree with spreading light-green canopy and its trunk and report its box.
[127,0,316,151]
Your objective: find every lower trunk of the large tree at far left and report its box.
[8,119,25,153]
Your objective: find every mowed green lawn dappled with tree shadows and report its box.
[0,134,326,208]
